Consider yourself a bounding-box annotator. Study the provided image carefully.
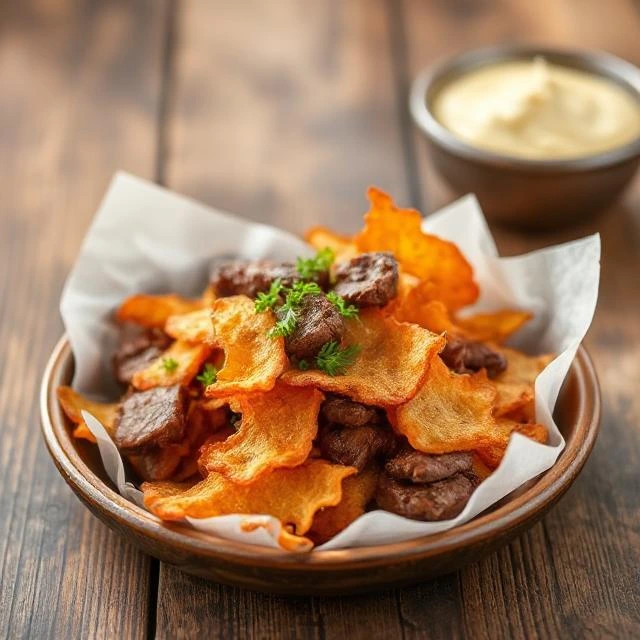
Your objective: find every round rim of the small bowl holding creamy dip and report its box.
[409,44,640,173]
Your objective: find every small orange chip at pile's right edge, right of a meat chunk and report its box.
[493,347,554,417]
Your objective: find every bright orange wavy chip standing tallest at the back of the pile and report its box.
[354,187,478,311]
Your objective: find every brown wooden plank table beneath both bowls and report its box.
[0,0,640,640]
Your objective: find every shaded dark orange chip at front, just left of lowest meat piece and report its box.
[308,469,379,544]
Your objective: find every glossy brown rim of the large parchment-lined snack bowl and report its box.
[40,335,601,571]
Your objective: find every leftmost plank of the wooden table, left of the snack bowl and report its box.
[0,0,168,638]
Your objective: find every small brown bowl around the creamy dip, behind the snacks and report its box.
[409,46,640,229]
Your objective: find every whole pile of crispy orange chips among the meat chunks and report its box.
[58,188,551,549]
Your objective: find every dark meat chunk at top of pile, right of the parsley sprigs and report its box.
[335,252,398,307]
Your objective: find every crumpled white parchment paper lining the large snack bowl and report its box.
[60,173,600,549]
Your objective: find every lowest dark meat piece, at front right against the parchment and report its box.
[375,471,480,521]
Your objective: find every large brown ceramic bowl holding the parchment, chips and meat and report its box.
[40,336,600,596]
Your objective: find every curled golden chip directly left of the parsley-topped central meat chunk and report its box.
[205,296,288,398]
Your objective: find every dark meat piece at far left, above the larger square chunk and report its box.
[113,323,171,384]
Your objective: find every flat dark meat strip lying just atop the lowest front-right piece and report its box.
[384,448,473,482]
